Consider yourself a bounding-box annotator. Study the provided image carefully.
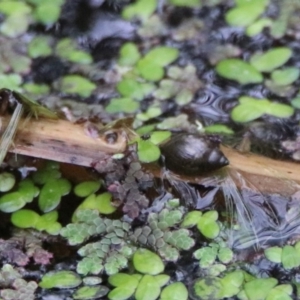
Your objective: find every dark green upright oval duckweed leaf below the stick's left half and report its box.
[38,179,62,212]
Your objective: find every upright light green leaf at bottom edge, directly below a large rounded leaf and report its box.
[134,275,160,300]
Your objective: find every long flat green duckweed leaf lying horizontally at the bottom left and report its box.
[39,271,81,289]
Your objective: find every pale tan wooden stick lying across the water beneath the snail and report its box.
[0,117,300,191]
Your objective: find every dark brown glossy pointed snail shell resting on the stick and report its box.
[160,133,229,176]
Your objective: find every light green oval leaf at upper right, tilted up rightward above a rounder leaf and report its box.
[250,47,293,72]
